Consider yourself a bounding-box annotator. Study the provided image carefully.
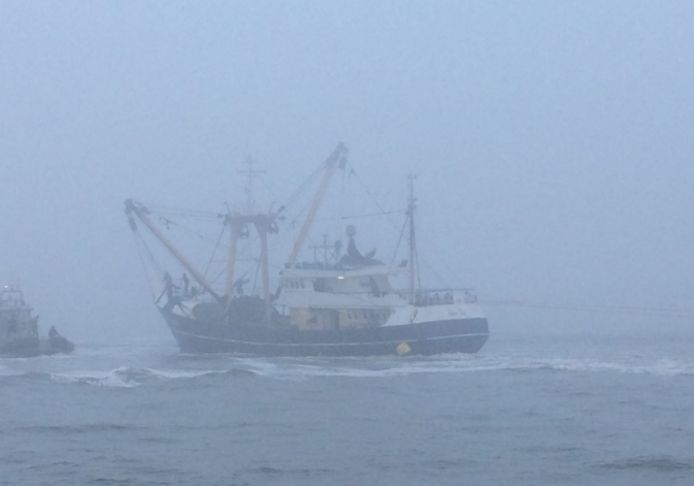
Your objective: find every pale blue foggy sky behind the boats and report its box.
[0,0,694,340]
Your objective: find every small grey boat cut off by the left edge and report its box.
[0,285,75,358]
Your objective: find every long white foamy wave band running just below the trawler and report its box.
[0,355,694,388]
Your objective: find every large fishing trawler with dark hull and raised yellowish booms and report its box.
[125,144,489,356]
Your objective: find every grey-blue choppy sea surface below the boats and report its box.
[0,324,694,486]
